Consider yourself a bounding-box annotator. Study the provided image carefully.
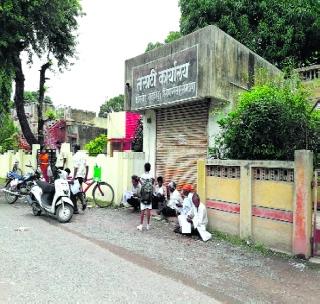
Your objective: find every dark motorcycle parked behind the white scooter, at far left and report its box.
[2,165,41,204]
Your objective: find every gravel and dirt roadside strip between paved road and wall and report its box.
[63,205,320,303]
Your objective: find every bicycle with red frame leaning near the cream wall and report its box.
[77,178,114,208]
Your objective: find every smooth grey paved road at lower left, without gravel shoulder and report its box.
[0,201,218,304]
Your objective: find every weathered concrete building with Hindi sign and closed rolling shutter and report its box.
[125,26,280,189]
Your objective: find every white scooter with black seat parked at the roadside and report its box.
[28,171,73,223]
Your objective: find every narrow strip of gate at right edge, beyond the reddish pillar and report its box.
[312,169,320,256]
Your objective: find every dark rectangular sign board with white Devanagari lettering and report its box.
[131,45,198,110]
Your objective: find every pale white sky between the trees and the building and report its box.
[24,0,180,112]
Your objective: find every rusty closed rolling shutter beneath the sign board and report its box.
[156,101,208,187]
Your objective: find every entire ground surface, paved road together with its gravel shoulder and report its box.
[0,196,320,304]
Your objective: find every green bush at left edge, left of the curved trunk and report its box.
[0,114,19,153]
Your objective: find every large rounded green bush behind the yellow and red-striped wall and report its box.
[209,79,320,160]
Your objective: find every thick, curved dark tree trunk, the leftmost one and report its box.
[14,54,38,147]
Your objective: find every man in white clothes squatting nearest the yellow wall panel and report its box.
[178,193,211,242]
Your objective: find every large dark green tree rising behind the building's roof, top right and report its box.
[179,0,320,67]
